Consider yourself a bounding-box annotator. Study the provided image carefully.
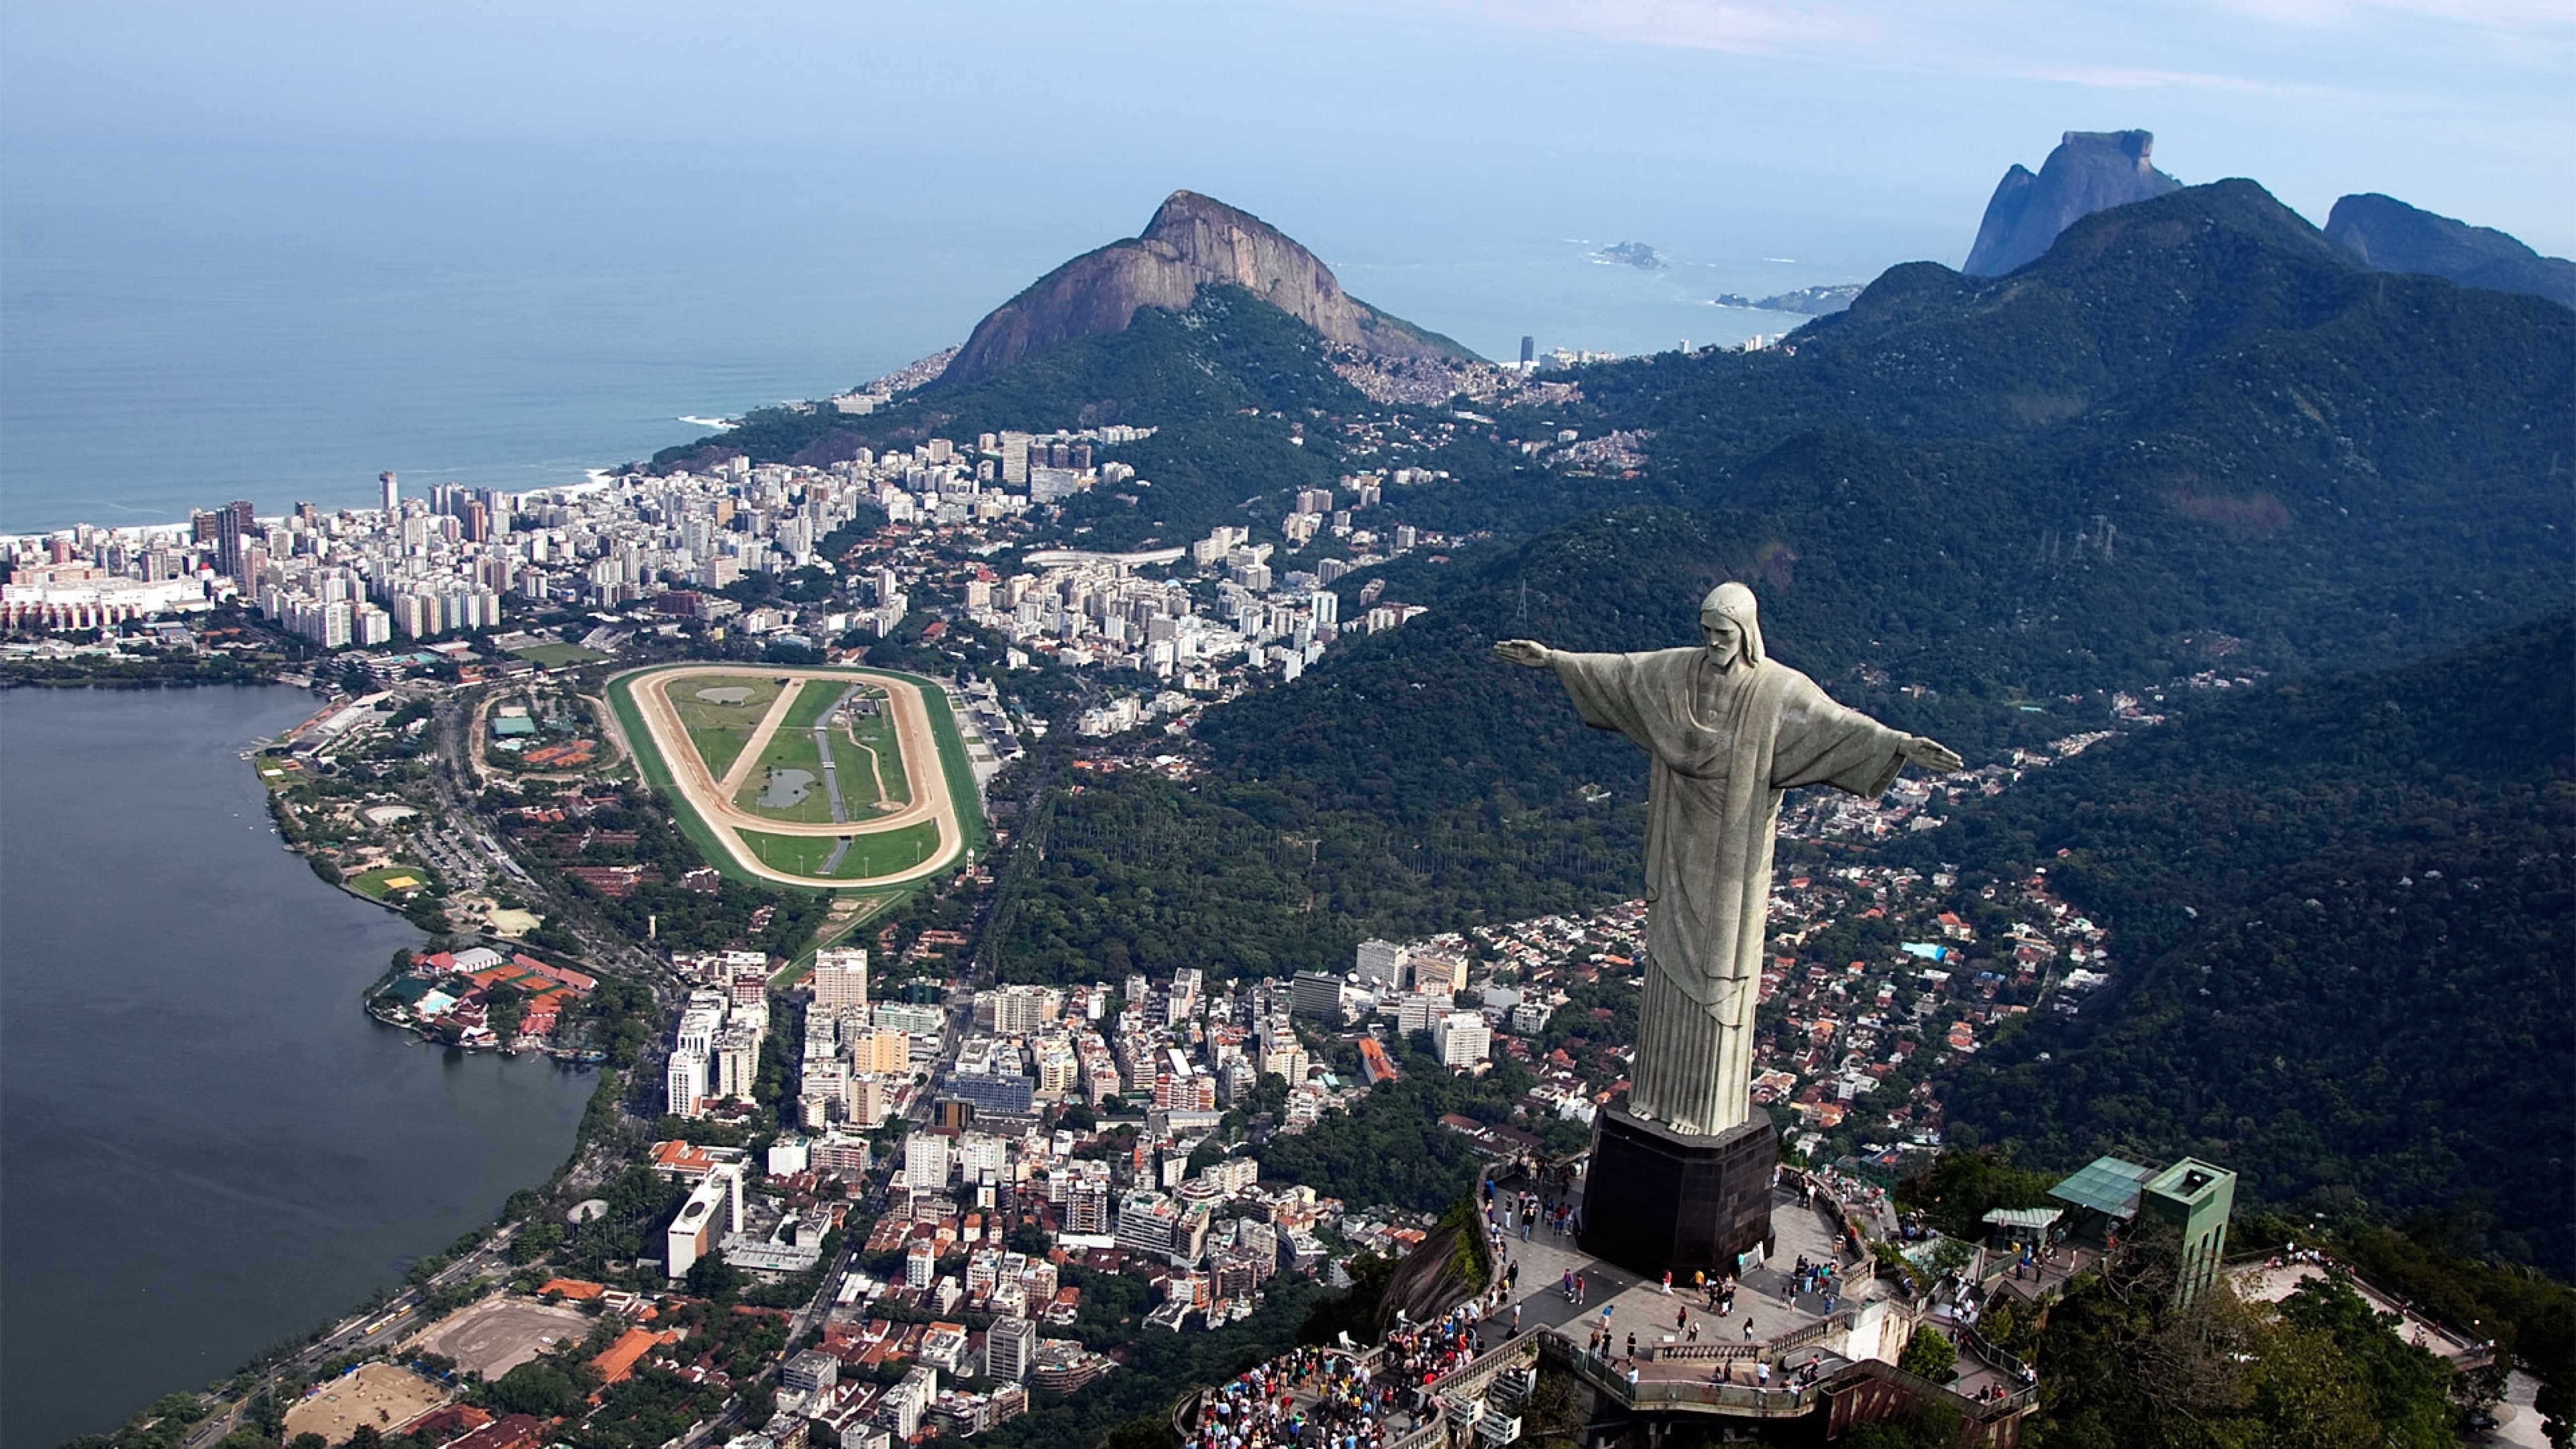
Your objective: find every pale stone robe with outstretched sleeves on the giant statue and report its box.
[1551,647,1904,1137]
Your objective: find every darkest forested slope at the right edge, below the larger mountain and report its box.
[1914,614,2576,1274]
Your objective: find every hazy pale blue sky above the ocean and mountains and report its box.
[0,0,2576,254]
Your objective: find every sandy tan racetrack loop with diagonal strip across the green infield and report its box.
[610,665,966,887]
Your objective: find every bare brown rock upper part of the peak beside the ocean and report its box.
[940,191,1471,384]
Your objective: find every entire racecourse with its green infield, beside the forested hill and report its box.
[608,665,984,887]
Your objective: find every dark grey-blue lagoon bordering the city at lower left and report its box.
[0,688,598,1446]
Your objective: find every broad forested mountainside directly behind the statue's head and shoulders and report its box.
[974,183,2576,1026]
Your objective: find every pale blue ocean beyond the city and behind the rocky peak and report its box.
[0,141,1940,534]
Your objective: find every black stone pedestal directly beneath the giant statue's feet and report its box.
[1582,1109,1780,1279]
